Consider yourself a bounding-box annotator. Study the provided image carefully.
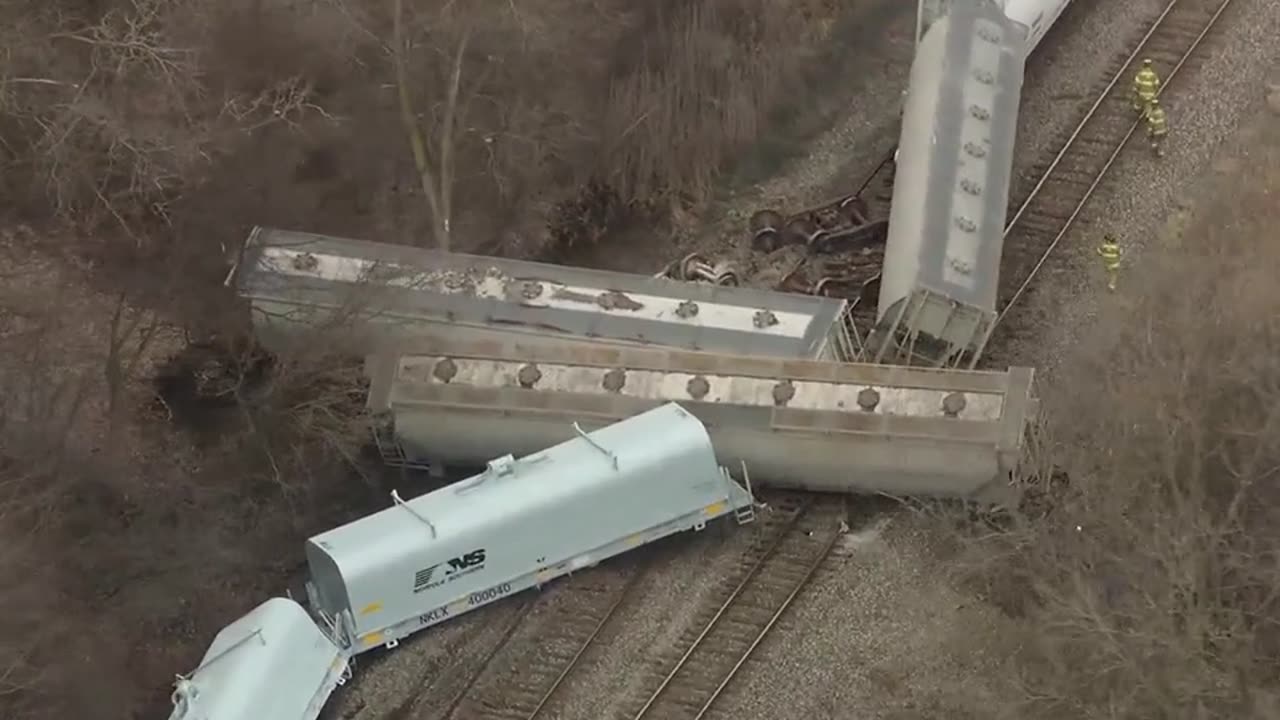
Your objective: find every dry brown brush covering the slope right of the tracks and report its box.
[931,132,1280,719]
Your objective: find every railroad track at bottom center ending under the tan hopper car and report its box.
[626,495,845,720]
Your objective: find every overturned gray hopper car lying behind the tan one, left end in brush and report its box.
[227,228,852,357]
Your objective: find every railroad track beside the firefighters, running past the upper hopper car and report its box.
[996,0,1231,325]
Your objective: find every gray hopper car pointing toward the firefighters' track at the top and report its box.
[873,0,1025,364]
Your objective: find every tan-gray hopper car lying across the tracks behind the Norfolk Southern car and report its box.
[369,333,1038,502]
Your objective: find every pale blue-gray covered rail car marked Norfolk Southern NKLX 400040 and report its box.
[306,404,753,652]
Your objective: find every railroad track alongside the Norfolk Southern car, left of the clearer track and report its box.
[442,562,648,720]
